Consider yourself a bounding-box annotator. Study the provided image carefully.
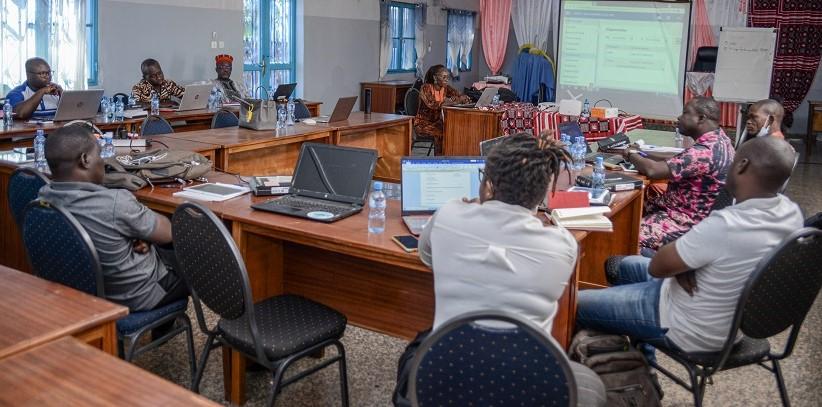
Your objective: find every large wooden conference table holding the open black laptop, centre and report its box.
[130,173,643,403]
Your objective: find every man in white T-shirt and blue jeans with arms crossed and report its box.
[576,137,802,358]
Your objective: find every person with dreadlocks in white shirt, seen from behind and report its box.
[394,133,605,406]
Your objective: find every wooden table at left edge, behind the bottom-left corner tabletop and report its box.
[0,266,128,358]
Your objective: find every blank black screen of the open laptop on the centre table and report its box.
[290,143,377,204]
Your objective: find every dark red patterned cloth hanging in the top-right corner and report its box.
[748,0,822,115]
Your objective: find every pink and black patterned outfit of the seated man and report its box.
[639,128,734,250]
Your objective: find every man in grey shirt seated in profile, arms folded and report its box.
[40,126,188,311]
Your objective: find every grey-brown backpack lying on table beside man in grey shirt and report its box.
[103,150,211,191]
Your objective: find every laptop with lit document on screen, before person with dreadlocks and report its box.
[400,157,485,235]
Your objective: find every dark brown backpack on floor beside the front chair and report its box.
[569,330,661,407]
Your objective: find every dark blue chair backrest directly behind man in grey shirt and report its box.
[23,201,105,297]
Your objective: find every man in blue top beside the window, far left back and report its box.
[6,58,63,120]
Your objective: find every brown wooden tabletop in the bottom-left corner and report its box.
[0,338,219,407]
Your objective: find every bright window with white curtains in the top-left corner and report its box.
[0,0,98,95]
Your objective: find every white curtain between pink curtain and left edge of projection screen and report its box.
[511,0,559,52]
